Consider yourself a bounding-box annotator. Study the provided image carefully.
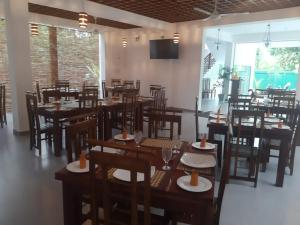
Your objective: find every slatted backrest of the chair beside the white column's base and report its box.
[26,92,41,131]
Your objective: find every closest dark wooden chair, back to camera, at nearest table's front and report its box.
[90,150,169,225]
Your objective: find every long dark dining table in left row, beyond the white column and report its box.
[38,97,153,156]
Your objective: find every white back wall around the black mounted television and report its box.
[105,23,202,109]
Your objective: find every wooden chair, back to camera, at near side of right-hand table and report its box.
[230,110,264,187]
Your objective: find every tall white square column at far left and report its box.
[4,0,32,133]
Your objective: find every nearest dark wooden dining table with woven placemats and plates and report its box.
[55,140,215,225]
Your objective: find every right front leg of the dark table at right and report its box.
[276,139,289,187]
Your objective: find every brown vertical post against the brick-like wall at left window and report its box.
[49,27,58,84]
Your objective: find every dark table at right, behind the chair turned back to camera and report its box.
[207,120,293,187]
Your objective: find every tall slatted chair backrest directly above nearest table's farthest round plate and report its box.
[122,93,138,133]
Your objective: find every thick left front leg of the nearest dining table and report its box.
[63,182,81,225]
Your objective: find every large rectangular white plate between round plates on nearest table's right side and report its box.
[180,152,216,168]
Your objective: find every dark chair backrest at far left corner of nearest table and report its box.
[66,116,97,162]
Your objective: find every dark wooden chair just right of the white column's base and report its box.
[26,92,55,155]
